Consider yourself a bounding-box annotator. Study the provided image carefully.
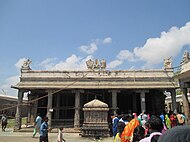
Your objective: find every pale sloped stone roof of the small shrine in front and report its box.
[84,99,108,108]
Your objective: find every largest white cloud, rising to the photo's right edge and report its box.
[134,22,190,66]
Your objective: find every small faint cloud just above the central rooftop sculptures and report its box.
[79,43,98,54]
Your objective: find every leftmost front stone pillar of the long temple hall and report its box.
[14,90,23,131]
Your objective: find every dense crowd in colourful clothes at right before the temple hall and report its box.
[111,112,190,142]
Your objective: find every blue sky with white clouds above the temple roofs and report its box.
[0,0,190,95]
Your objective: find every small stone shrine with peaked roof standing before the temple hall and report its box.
[81,99,109,137]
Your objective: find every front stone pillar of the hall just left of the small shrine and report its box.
[72,90,84,129]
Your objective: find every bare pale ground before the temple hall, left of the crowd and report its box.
[0,128,113,142]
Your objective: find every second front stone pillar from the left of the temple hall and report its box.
[47,90,54,128]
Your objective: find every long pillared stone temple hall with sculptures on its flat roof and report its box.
[12,59,178,129]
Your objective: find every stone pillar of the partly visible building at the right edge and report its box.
[181,85,190,123]
